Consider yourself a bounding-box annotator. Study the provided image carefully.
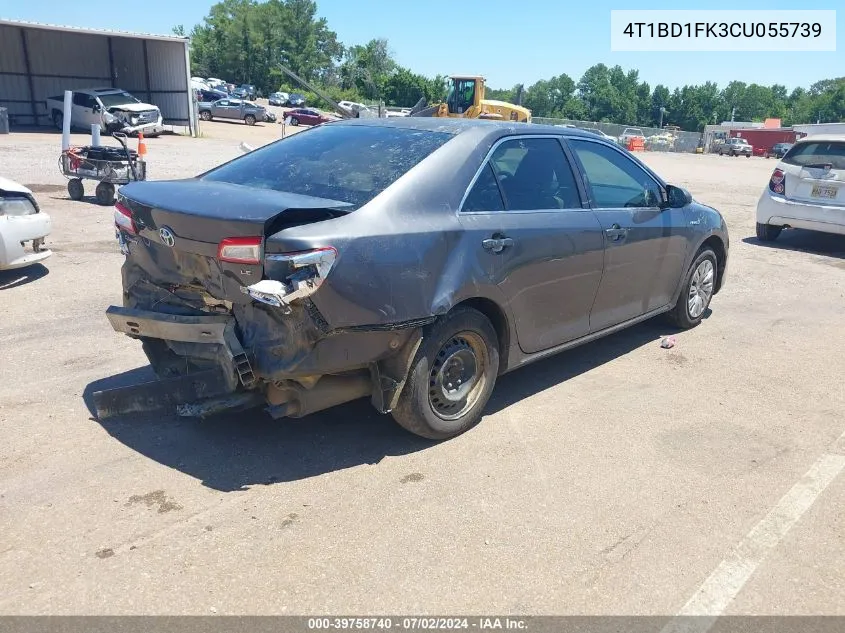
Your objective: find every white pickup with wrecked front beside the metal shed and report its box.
[45,88,164,137]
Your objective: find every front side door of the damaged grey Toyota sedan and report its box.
[567,138,689,332]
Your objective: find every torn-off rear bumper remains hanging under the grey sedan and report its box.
[93,306,428,419]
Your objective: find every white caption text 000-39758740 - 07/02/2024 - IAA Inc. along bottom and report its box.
[308,617,528,631]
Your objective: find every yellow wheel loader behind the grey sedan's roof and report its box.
[408,75,531,123]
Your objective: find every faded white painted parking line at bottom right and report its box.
[661,433,845,633]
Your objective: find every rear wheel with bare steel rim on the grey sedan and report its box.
[392,308,499,440]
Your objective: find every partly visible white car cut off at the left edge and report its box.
[0,177,53,270]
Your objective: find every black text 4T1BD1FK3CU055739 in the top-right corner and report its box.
[622,22,822,38]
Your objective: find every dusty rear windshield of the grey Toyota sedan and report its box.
[202,123,452,207]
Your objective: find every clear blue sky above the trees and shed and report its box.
[0,0,845,90]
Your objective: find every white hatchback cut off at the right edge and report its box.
[757,135,845,242]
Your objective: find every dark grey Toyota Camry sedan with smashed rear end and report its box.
[102,117,729,439]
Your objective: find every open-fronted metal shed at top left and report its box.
[0,20,197,135]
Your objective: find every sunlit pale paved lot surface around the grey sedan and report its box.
[0,123,845,615]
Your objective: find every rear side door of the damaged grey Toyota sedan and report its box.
[460,135,604,353]
